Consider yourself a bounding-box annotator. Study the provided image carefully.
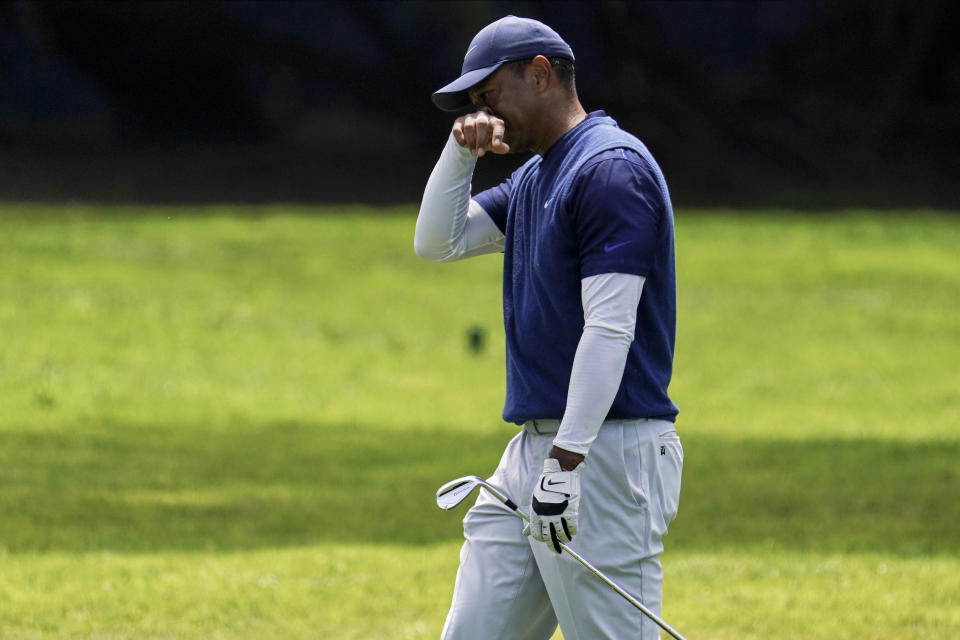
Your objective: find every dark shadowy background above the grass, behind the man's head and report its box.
[0,0,960,209]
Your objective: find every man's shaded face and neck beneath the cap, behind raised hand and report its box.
[467,62,537,153]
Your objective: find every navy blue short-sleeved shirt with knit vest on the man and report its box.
[474,111,677,424]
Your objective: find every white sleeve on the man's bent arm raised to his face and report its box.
[413,133,504,262]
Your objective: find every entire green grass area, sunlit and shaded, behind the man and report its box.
[0,205,960,640]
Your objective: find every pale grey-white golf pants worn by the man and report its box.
[442,420,683,640]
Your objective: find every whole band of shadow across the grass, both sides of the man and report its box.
[0,424,960,554]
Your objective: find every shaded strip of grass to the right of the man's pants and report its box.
[669,439,960,555]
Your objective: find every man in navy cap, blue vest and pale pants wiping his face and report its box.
[414,16,683,640]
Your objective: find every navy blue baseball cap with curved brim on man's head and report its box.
[433,16,574,111]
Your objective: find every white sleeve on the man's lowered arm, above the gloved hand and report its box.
[553,273,644,455]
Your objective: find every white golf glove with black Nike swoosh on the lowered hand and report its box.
[523,458,583,553]
